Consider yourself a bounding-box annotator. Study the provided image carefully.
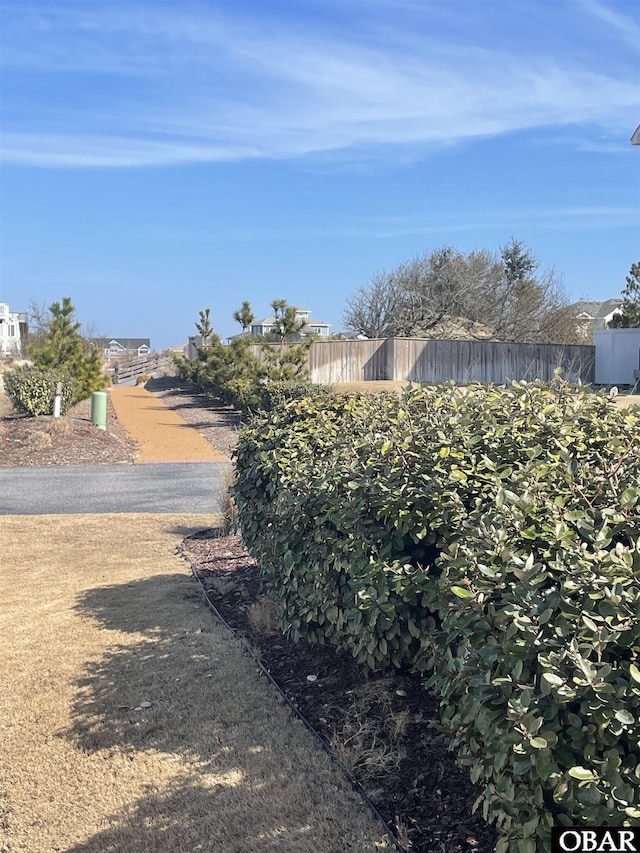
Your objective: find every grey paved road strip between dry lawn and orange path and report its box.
[0,462,229,515]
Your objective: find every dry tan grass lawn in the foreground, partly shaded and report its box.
[0,515,389,853]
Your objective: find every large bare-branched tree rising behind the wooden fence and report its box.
[344,240,578,343]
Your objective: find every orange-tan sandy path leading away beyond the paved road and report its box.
[109,385,227,463]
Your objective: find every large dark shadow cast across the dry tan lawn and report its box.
[58,574,380,853]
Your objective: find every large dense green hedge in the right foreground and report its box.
[234,383,640,853]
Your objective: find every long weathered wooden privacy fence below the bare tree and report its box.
[249,338,595,385]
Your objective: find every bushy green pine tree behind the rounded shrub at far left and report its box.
[31,296,106,403]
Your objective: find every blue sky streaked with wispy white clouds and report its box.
[0,0,640,348]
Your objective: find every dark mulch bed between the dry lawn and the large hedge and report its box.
[183,530,497,853]
